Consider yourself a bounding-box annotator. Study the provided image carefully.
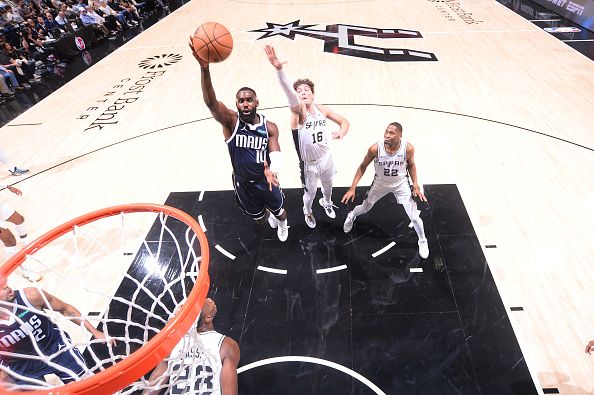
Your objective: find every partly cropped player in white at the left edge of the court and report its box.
[0,185,41,282]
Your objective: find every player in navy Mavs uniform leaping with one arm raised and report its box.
[189,38,289,241]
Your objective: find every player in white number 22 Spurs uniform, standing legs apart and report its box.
[341,122,429,259]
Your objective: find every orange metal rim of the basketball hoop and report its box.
[0,203,210,395]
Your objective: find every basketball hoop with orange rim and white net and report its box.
[0,203,209,395]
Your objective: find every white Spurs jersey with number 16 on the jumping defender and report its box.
[297,104,330,162]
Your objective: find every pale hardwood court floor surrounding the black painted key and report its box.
[0,0,594,394]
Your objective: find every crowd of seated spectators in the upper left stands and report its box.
[0,0,168,104]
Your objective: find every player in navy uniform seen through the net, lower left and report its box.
[0,278,116,388]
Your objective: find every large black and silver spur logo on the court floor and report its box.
[251,20,437,62]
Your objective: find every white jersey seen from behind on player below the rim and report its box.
[167,328,225,395]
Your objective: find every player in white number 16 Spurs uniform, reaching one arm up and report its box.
[265,45,349,228]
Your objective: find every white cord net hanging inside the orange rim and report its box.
[0,206,208,394]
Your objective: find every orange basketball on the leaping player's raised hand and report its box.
[192,22,233,63]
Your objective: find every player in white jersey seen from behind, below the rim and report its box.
[142,298,240,395]
